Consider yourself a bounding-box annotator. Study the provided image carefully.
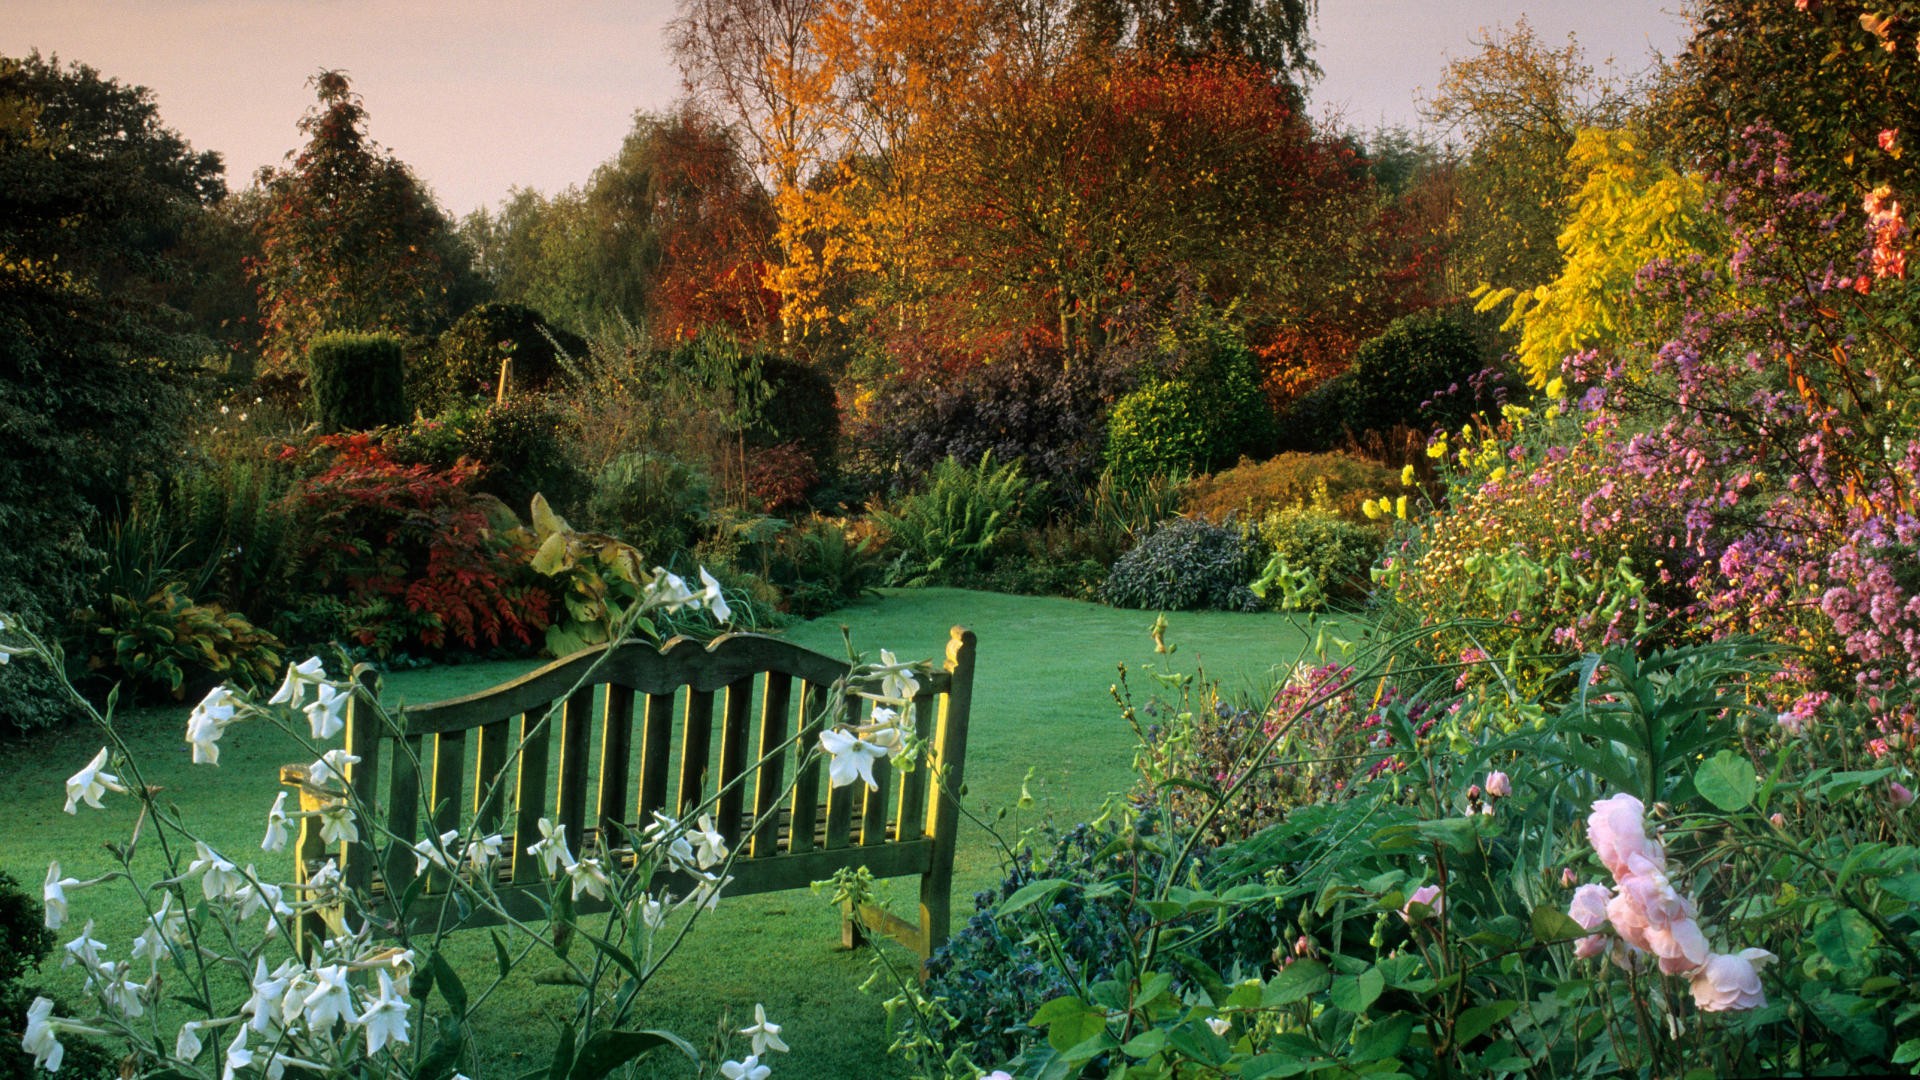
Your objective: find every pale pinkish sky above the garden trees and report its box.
[0,0,1686,215]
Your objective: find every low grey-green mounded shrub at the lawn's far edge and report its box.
[1100,517,1265,611]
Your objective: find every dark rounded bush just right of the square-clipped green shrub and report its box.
[420,304,588,413]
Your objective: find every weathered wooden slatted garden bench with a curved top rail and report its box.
[280,626,975,959]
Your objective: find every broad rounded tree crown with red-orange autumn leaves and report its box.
[933,56,1367,356]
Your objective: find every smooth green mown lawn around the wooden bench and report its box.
[0,590,1336,1078]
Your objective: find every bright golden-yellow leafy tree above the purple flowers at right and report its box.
[1473,129,1724,386]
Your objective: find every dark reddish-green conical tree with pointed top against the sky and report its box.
[252,71,465,371]
